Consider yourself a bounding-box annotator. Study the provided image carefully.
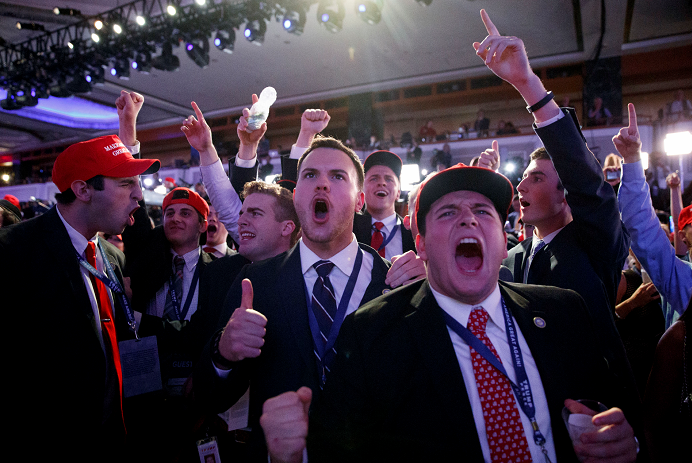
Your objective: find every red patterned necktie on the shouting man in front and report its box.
[467,307,531,463]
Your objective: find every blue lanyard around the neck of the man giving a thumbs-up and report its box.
[303,247,363,384]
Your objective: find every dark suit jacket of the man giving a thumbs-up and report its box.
[193,245,389,462]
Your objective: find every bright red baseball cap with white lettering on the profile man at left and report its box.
[53,135,161,193]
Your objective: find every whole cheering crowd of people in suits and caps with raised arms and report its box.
[0,10,692,462]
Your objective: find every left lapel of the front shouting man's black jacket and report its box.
[406,281,483,461]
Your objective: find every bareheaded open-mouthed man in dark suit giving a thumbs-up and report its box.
[193,139,389,461]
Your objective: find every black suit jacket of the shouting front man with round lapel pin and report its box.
[308,280,639,462]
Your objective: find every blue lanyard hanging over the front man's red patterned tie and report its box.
[442,299,549,461]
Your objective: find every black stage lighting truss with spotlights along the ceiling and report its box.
[0,0,410,95]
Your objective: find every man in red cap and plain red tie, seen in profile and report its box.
[0,130,160,461]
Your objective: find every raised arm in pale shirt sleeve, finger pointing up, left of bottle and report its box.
[180,101,242,242]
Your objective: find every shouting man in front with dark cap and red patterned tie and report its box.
[261,164,637,462]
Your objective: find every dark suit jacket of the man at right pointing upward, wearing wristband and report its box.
[503,109,643,392]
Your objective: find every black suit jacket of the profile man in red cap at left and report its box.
[0,208,132,461]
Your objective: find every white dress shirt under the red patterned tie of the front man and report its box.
[431,286,557,462]
